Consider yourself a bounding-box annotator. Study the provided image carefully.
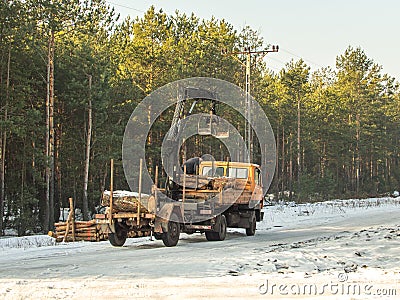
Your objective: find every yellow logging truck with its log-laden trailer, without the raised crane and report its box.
[96,161,263,247]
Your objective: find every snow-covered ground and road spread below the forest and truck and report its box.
[0,197,400,299]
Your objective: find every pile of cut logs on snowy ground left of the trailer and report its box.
[52,220,108,242]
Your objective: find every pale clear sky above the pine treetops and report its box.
[107,0,400,81]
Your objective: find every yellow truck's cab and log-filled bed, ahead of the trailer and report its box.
[171,161,263,236]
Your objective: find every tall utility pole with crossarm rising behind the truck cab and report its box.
[221,45,279,162]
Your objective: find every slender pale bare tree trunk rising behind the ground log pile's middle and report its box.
[82,75,92,221]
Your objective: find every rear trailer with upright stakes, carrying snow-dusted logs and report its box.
[95,160,184,247]
